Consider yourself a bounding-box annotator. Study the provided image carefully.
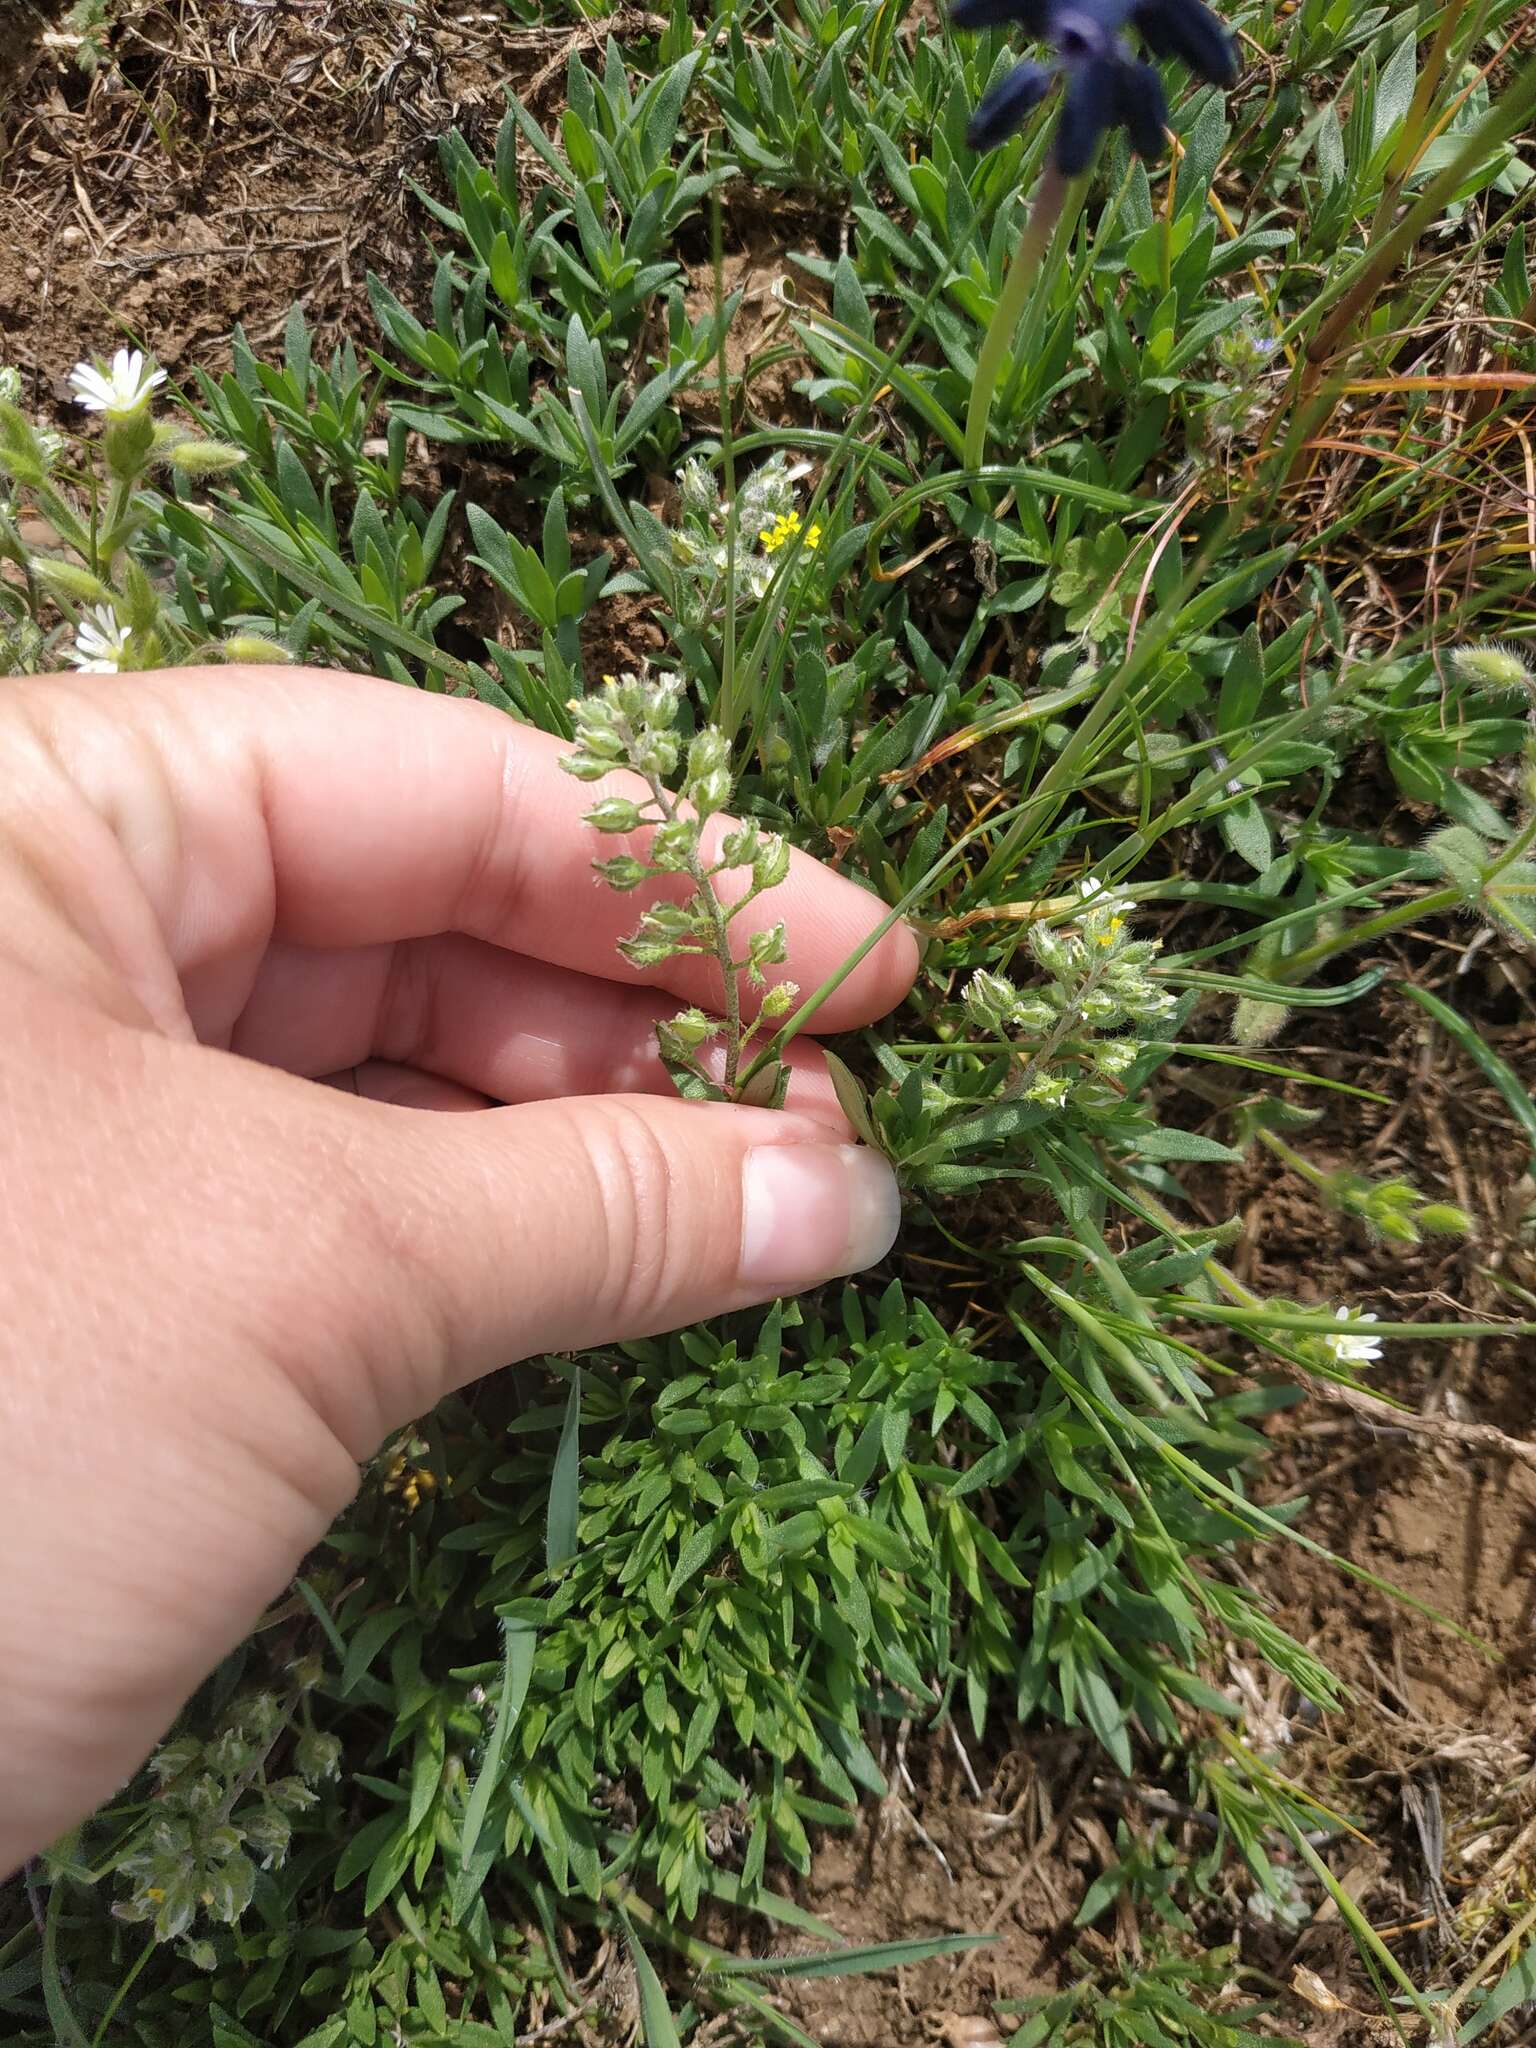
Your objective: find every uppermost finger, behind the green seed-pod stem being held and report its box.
[27,668,918,1030]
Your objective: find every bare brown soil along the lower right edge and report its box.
[1179,928,1536,2044]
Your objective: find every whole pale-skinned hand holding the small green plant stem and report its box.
[0,668,915,1874]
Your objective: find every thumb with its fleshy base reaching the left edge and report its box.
[0,999,899,1874]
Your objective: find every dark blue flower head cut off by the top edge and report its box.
[950,0,1237,178]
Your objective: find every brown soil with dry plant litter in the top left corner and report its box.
[0,0,514,397]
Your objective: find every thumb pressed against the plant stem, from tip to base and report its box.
[368,1096,899,1409]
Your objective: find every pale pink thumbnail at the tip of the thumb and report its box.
[741,1145,901,1294]
